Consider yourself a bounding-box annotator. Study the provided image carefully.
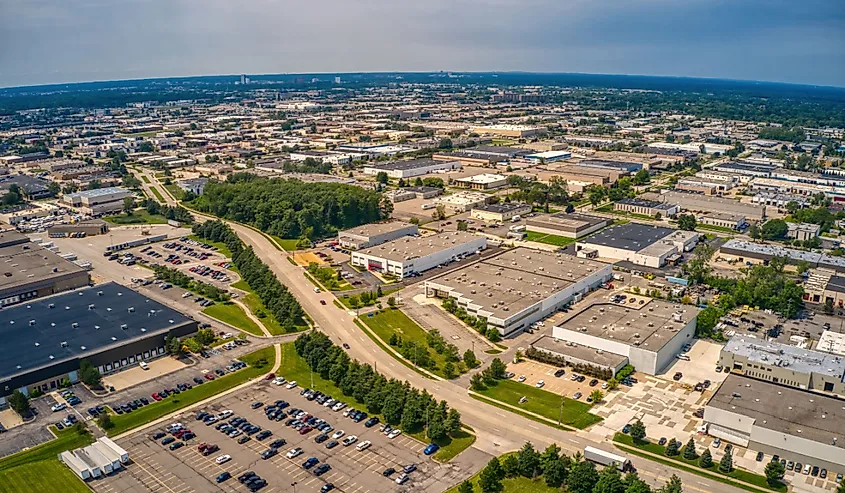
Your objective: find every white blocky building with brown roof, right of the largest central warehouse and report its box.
[552,297,701,375]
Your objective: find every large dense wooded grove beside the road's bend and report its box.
[192,173,393,239]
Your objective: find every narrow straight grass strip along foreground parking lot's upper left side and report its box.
[108,346,276,436]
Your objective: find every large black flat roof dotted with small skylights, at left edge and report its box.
[0,282,193,377]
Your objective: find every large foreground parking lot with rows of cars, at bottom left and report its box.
[99,381,468,493]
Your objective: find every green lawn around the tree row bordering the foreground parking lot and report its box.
[276,342,468,462]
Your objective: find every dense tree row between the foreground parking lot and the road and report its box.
[294,331,461,441]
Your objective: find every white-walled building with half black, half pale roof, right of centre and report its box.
[576,223,701,267]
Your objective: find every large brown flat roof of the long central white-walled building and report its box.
[426,247,608,318]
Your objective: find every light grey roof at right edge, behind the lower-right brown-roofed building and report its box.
[722,336,845,381]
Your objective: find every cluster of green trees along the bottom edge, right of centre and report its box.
[458,443,683,493]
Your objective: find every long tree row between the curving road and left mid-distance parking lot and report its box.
[192,220,305,332]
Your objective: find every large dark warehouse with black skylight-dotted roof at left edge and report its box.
[0,282,197,406]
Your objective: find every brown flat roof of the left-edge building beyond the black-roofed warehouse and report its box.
[0,242,85,290]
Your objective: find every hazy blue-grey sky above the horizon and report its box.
[0,0,845,87]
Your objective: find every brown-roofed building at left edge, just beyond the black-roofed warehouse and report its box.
[0,231,90,307]
